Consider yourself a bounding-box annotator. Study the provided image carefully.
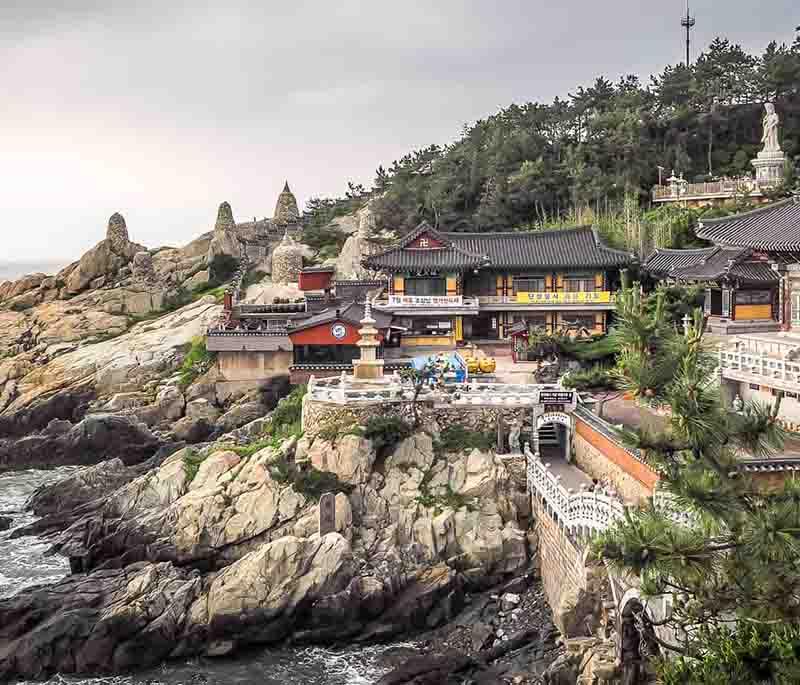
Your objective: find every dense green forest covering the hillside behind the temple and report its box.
[360,39,800,247]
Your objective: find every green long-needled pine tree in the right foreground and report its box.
[595,288,800,685]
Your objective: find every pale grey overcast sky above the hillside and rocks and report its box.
[0,0,800,263]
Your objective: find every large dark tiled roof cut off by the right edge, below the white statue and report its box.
[697,196,800,251]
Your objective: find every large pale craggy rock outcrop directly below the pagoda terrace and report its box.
[0,428,529,677]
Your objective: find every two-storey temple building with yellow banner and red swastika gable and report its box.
[364,222,633,346]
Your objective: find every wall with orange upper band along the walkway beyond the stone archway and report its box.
[573,417,658,504]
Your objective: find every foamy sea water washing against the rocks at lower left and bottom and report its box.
[0,467,414,685]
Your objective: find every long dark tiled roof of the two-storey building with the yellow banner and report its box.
[364,224,634,271]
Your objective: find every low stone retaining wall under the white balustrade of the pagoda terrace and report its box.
[303,397,530,436]
